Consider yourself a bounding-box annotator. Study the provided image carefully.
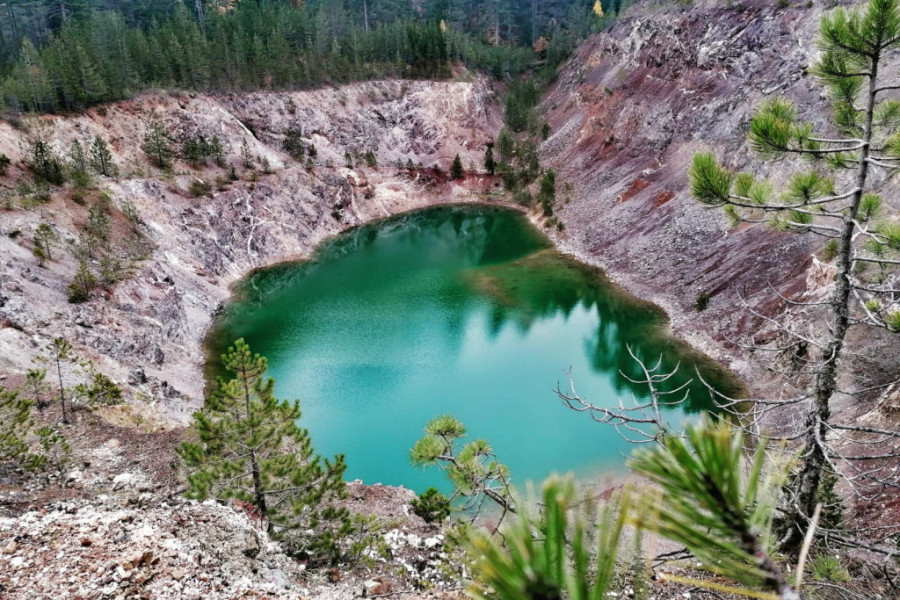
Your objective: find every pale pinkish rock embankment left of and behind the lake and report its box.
[0,79,501,422]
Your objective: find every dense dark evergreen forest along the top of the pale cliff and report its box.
[0,0,608,112]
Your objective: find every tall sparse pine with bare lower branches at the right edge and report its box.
[690,0,900,551]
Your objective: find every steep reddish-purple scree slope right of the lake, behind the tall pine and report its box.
[542,1,896,398]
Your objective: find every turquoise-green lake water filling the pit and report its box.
[209,206,738,492]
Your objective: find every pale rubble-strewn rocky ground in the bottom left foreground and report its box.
[0,477,459,600]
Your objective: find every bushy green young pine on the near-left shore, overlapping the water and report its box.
[178,340,350,562]
